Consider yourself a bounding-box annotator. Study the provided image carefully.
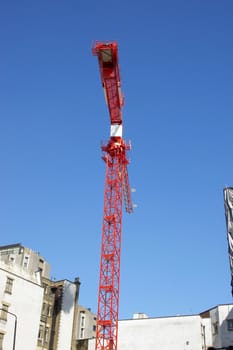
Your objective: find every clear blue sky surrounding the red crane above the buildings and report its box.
[0,0,233,318]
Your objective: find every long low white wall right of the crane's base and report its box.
[118,316,202,350]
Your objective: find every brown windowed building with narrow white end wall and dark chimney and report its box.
[37,278,80,350]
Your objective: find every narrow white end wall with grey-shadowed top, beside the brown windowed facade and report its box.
[57,281,76,350]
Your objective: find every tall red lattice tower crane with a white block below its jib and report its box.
[92,42,133,350]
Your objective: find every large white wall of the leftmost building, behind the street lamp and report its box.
[0,263,43,350]
